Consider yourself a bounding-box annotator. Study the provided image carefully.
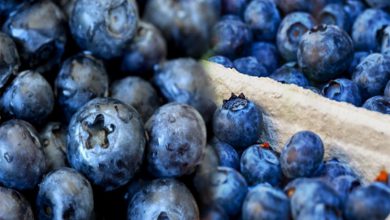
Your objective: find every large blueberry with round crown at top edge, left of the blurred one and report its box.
[69,0,138,59]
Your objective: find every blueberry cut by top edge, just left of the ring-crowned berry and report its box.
[244,0,281,41]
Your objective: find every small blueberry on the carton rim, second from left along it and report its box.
[233,57,269,77]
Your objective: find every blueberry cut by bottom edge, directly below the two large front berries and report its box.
[127,179,199,220]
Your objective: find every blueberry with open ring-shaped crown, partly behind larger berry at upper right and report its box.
[276,12,315,61]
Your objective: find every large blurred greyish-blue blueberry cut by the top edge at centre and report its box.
[144,0,219,57]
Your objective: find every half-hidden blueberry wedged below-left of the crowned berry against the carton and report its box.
[210,138,240,170]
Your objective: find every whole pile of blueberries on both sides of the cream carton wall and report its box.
[0,0,390,220]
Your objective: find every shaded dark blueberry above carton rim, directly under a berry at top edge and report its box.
[244,42,280,73]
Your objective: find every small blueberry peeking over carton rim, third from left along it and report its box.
[269,62,310,88]
